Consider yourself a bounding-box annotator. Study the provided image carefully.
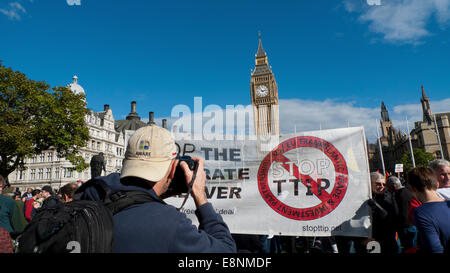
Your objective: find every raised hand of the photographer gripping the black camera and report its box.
[180,157,208,208]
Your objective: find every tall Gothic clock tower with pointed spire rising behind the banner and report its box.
[250,33,280,136]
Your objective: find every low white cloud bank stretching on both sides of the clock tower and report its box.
[152,98,450,143]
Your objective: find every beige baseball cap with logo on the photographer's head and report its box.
[120,125,177,182]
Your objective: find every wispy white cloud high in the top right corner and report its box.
[344,0,450,44]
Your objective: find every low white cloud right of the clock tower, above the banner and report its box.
[280,98,450,143]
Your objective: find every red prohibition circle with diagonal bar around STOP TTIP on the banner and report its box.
[258,136,348,221]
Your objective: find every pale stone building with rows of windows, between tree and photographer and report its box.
[8,76,135,192]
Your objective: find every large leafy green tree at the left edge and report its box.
[0,62,90,183]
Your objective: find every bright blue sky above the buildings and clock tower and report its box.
[0,0,450,138]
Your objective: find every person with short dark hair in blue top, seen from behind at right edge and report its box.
[407,167,450,253]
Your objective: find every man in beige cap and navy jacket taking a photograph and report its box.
[83,125,236,253]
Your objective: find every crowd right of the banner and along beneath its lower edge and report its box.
[256,159,450,254]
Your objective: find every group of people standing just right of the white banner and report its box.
[356,159,450,253]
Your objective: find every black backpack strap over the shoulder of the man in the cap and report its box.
[104,191,165,215]
